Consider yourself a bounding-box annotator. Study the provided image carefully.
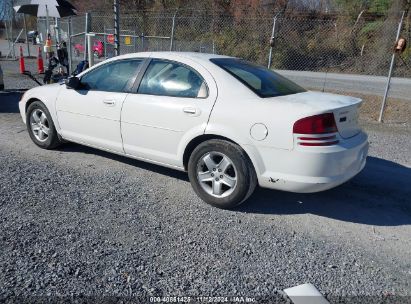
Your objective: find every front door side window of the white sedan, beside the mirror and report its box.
[81,59,143,93]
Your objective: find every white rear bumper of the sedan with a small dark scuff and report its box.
[258,132,369,193]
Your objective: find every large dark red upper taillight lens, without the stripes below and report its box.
[293,113,338,134]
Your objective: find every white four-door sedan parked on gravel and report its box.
[19,52,368,208]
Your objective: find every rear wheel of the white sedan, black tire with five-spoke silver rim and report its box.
[188,139,257,209]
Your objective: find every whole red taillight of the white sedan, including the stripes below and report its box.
[293,113,339,146]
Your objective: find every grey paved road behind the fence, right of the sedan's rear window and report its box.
[277,70,411,101]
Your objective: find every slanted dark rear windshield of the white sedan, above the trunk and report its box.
[210,58,306,98]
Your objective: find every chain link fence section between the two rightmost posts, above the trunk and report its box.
[273,18,398,75]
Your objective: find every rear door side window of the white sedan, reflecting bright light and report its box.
[138,59,208,98]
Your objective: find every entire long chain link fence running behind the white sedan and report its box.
[33,11,411,77]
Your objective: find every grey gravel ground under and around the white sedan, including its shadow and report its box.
[0,62,411,303]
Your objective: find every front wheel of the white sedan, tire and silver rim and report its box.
[26,101,62,149]
